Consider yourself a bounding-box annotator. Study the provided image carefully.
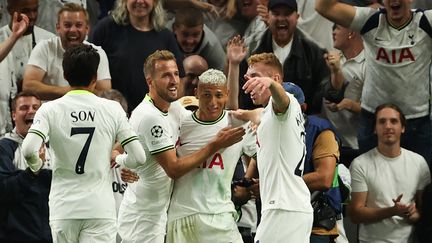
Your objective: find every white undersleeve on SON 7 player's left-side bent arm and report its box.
[22,132,43,172]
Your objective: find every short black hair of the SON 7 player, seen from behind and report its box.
[62,44,100,87]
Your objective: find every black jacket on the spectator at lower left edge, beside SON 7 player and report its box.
[0,138,52,243]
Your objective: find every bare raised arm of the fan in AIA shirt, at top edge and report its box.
[315,0,356,27]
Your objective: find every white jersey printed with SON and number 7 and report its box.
[29,90,138,220]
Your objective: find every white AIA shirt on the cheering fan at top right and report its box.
[350,7,432,119]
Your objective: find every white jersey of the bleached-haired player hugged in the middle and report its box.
[168,111,256,221]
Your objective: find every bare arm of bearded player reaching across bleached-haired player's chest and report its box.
[154,127,245,179]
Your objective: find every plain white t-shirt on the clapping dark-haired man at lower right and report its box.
[350,148,431,243]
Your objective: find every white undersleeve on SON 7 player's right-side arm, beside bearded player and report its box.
[115,139,147,169]
